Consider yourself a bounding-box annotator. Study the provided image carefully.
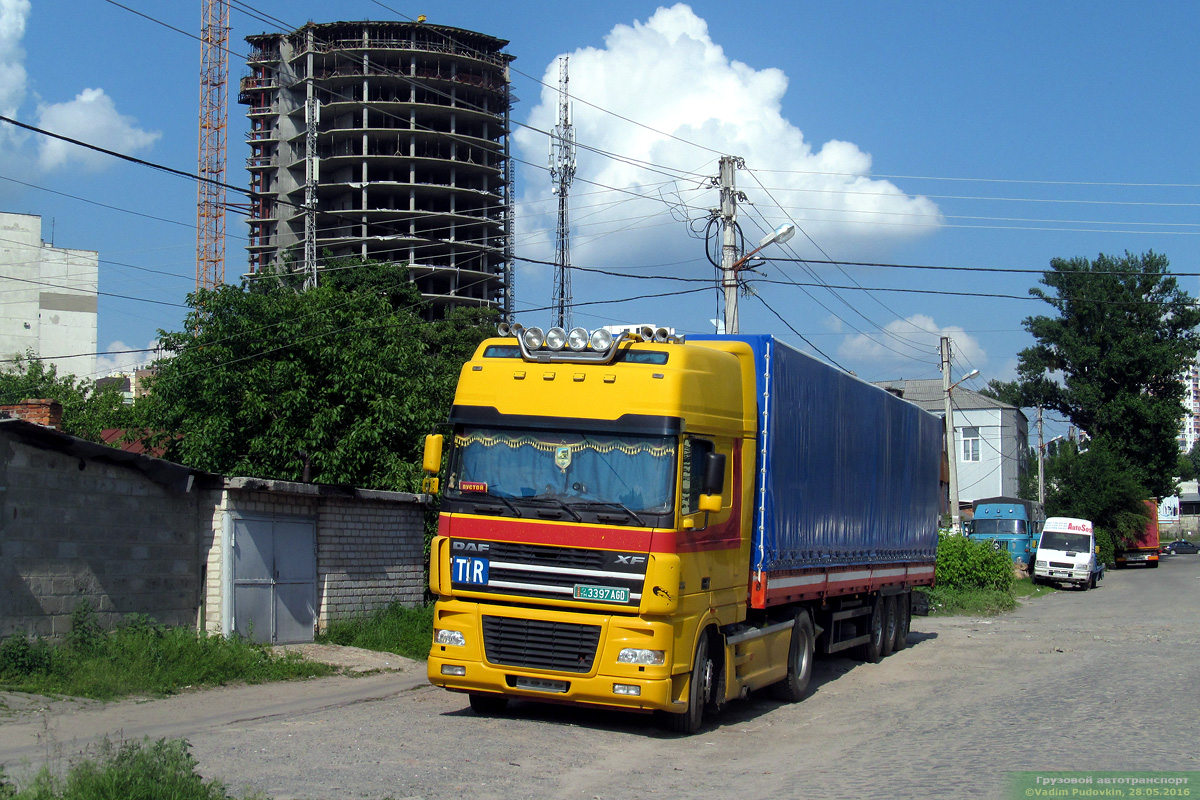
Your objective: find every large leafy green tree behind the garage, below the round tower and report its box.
[144,263,494,491]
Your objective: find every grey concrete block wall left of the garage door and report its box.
[0,437,199,638]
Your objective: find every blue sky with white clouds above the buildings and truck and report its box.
[0,0,1200,438]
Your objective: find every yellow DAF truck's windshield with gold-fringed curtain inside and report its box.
[446,428,676,515]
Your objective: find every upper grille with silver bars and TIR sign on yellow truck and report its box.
[450,539,649,608]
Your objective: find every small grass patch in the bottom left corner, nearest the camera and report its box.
[0,739,253,800]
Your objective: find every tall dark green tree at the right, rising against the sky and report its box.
[1018,252,1200,497]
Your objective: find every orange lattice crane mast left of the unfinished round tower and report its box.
[196,0,229,289]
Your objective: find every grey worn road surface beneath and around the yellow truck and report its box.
[0,555,1200,800]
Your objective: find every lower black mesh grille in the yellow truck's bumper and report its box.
[484,616,600,673]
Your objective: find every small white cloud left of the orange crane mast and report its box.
[37,89,162,172]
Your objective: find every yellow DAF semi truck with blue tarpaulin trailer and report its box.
[426,325,942,733]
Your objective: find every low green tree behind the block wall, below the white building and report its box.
[0,351,134,443]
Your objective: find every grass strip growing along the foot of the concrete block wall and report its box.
[0,603,337,700]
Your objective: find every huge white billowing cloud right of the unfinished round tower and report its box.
[515,4,941,272]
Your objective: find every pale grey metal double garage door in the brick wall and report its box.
[232,517,317,644]
